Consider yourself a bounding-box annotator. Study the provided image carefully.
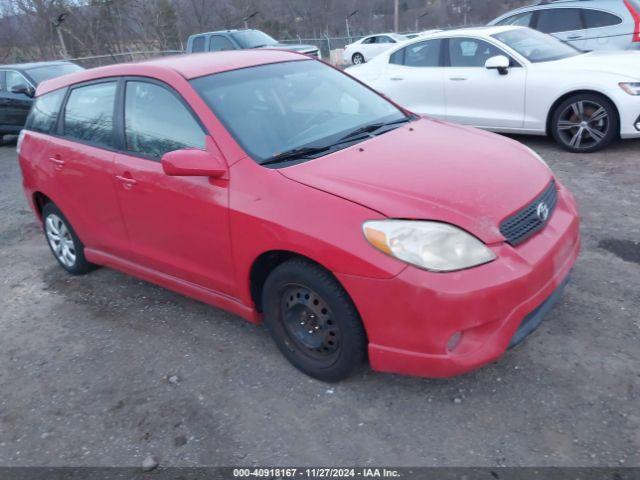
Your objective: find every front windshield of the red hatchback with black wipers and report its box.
[191,60,412,165]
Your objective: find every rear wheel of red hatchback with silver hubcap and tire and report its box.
[42,203,96,275]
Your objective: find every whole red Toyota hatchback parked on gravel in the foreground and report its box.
[18,50,580,381]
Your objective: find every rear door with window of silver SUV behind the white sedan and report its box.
[534,7,587,50]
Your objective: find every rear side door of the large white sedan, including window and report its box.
[377,39,446,119]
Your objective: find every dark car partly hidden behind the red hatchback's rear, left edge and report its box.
[0,62,83,144]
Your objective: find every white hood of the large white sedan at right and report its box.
[550,50,640,78]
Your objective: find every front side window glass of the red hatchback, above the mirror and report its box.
[124,81,205,160]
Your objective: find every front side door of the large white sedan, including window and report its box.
[444,37,527,129]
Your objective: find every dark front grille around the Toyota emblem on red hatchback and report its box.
[500,181,558,246]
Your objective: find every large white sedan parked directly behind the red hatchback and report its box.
[347,27,640,153]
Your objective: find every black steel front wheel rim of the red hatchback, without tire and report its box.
[281,284,340,364]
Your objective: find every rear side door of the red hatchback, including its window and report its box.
[47,80,129,257]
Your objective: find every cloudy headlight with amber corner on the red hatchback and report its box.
[362,220,496,272]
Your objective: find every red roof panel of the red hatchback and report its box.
[38,49,308,95]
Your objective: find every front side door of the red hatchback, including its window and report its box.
[113,79,233,294]
